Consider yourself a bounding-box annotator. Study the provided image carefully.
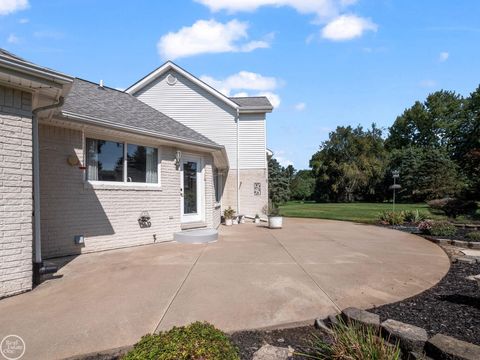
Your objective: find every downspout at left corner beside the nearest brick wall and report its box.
[32,96,64,284]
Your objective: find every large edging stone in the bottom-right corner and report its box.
[425,334,480,360]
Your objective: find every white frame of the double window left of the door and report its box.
[83,135,162,188]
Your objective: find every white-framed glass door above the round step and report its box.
[180,156,203,223]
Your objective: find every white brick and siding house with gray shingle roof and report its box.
[0,50,272,298]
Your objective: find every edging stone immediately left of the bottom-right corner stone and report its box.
[382,319,428,352]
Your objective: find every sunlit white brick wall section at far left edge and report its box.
[0,86,33,298]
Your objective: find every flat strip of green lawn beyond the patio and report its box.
[280,201,444,223]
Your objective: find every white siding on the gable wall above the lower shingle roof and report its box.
[133,70,239,169]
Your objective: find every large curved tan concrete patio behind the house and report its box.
[0,219,449,359]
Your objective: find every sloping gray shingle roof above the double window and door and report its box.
[62,78,220,147]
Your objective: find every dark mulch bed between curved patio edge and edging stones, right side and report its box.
[369,262,480,345]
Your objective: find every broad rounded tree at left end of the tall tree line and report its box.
[310,124,386,201]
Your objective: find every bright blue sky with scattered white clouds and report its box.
[0,0,480,168]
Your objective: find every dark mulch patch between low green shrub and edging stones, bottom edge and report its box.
[231,325,324,360]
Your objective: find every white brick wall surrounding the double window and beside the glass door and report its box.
[40,125,218,258]
